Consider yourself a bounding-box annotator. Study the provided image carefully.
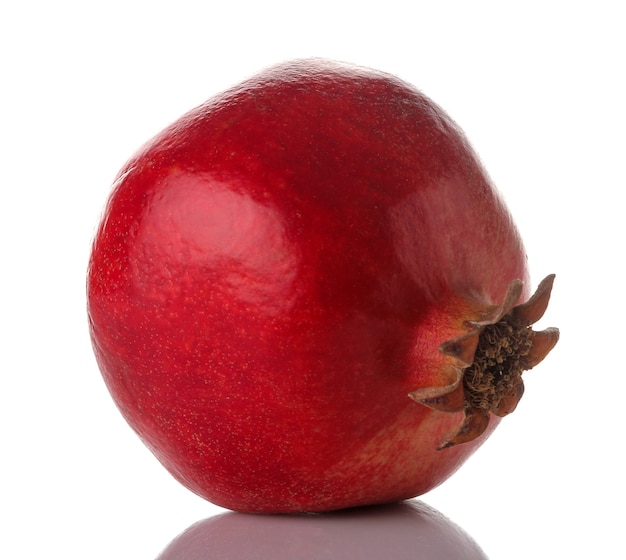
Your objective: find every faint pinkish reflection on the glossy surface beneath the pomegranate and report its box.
[158,502,487,560]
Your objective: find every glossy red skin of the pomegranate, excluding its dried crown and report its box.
[88,60,527,512]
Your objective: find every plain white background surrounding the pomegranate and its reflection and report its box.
[0,0,626,560]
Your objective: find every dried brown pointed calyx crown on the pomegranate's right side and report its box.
[409,275,559,449]
